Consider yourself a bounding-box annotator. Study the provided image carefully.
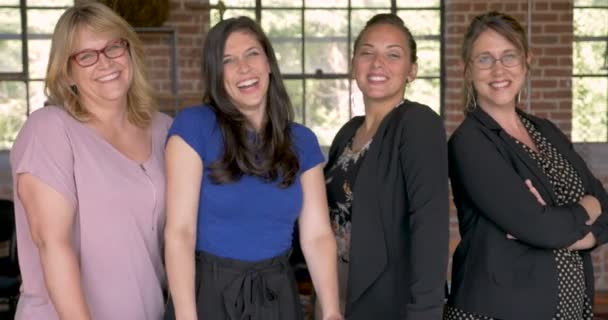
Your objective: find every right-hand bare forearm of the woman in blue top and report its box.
[301,232,340,317]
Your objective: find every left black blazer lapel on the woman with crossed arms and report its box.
[473,107,556,203]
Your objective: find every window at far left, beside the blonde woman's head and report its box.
[0,0,73,150]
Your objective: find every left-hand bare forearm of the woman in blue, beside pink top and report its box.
[165,231,197,320]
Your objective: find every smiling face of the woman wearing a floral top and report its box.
[353,24,418,105]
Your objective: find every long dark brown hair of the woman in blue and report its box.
[202,17,300,188]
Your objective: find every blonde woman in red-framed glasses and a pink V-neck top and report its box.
[11,2,171,320]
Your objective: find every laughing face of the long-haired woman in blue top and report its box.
[223,31,270,111]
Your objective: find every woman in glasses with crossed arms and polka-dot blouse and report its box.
[444,12,608,320]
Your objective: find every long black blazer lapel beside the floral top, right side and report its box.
[346,114,390,308]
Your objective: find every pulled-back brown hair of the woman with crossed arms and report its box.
[460,11,530,111]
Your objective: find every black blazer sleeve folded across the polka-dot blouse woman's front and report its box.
[448,123,590,249]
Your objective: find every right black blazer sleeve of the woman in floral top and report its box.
[399,107,449,320]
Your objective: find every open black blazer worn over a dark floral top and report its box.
[326,101,449,320]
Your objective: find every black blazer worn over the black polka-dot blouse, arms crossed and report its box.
[448,108,608,320]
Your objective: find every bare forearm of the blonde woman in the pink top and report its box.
[38,243,91,320]
